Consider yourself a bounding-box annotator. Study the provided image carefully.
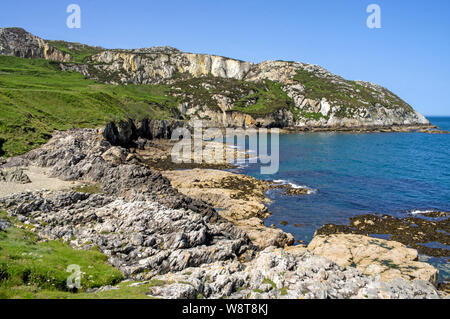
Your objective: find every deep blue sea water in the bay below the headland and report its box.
[237,117,450,280]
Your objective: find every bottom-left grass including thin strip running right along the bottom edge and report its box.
[0,227,164,299]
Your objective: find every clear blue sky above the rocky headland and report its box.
[0,0,450,115]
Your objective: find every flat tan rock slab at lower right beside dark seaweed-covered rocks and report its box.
[308,234,439,285]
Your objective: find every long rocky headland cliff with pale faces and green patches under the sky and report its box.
[0,29,429,129]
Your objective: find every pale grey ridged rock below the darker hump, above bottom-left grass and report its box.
[0,192,248,279]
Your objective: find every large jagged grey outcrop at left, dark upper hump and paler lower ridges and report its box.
[0,130,253,278]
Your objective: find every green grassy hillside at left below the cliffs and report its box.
[0,56,176,156]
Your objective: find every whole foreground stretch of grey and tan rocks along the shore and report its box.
[0,129,441,298]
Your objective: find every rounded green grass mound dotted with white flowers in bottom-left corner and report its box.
[0,227,123,298]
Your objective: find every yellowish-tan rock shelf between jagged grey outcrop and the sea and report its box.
[162,169,294,249]
